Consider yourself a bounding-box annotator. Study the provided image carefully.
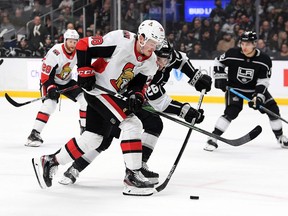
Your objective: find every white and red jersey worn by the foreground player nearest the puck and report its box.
[77,30,158,94]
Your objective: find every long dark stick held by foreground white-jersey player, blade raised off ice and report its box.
[93,84,262,146]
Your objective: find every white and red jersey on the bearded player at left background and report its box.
[41,43,77,87]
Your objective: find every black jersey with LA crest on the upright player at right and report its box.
[214,47,272,94]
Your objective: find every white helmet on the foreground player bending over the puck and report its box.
[138,20,165,44]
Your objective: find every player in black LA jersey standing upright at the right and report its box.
[204,31,288,151]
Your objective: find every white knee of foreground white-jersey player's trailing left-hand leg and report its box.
[76,131,103,153]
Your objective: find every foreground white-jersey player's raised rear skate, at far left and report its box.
[32,155,58,189]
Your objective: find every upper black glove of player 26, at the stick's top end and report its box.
[188,69,212,92]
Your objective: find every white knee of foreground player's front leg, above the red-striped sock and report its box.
[119,115,143,140]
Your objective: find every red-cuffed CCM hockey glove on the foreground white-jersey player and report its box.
[77,67,96,91]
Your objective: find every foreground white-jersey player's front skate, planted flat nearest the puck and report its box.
[123,168,154,196]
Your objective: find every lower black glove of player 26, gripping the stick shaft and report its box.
[179,103,205,124]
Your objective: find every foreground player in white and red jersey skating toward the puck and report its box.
[32,20,165,196]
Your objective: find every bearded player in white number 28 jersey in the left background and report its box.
[25,29,87,147]
